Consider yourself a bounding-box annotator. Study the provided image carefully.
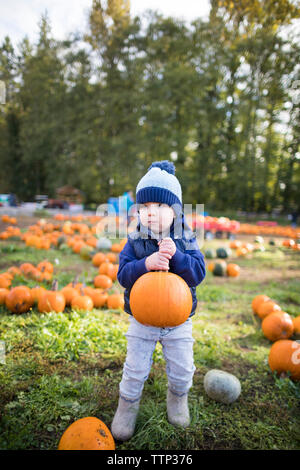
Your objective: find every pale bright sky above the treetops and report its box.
[0,0,210,46]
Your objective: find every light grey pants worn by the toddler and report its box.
[119,316,196,401]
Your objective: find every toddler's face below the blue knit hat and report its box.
[139,202,175,233]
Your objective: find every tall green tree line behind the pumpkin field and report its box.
[0,0,300,211]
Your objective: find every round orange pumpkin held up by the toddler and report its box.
[130,271,193,328]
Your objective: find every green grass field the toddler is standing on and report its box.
[0,229,300,450]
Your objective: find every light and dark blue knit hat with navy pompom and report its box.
[136,160,182,206]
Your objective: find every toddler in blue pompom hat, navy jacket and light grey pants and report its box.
[111,160,205,441]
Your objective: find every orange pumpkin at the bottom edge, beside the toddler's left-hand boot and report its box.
[58,416,116,450]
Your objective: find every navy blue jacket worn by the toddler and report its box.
[117,214,205,317]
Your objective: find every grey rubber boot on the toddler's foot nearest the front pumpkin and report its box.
[111,397,140,441]
